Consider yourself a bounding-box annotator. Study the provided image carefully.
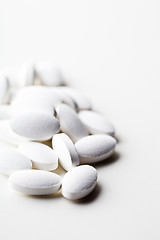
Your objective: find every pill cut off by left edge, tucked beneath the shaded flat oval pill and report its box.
[0,120,29,145]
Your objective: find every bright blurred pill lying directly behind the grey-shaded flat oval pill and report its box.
[11,86,62,115]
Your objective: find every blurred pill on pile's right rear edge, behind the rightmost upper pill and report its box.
[60,87,92,110]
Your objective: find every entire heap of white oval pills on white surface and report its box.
[0,63,116,200]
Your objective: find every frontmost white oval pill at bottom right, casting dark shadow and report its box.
[62,165,97,200]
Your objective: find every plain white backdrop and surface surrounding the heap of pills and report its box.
[0,0,160,240]
